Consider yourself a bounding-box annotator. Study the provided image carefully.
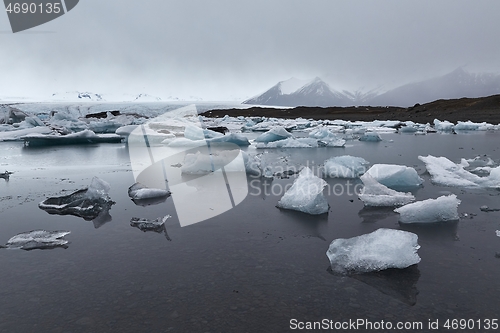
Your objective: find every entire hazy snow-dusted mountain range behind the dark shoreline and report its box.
[243,68,500,107]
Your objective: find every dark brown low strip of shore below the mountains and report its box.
[203,95,500,124]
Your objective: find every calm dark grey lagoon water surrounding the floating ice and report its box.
[0,132,500,332]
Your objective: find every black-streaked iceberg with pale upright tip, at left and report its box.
[38,177,115,220]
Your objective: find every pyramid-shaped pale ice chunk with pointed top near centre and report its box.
[277,167,329,215]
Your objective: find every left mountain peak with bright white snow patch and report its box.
[243,77,350,106]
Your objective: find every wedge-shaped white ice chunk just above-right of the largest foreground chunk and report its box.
[394,194,460,223]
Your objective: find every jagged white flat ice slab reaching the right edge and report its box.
[418,155,500,188]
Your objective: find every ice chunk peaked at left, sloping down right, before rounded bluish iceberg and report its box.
[358,174,415,206]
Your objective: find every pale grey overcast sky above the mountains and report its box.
[0,0,500,100]
